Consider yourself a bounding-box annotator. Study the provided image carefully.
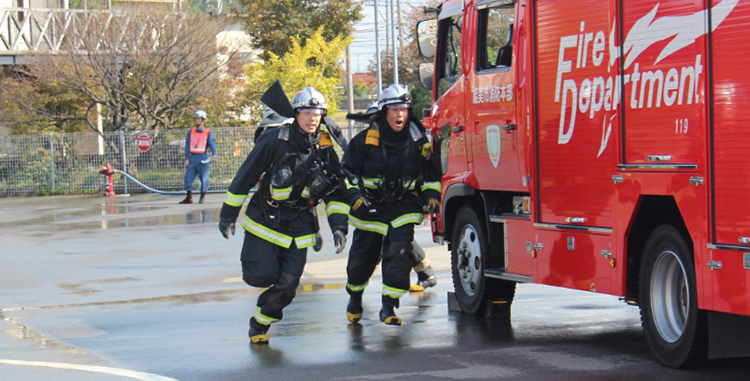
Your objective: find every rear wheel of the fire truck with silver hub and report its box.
[640,225,708,368]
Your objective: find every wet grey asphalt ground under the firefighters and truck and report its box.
[0,194,750,380]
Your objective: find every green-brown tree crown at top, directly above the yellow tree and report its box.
[237,0,362,60]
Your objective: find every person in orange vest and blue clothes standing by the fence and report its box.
[180,110,216,204]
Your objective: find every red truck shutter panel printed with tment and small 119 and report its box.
[620,0,706,166]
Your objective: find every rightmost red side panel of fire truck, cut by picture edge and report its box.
[710,0,750,314]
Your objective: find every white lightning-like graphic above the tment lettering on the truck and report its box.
[624,0,739,69]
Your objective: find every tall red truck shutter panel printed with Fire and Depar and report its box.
[534,0,621,228]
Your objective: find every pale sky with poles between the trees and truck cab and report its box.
[351,0,426,73]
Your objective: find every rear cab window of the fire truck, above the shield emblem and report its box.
[477,6,514,71]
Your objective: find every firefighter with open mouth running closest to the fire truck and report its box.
[342,85,441,325]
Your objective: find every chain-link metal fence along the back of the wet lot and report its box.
[0,125,363,196]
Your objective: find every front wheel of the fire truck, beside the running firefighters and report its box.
[451,205,489,315]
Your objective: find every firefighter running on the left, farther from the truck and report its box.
[219,87,349,344]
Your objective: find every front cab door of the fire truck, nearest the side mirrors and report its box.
[431,2,470,175]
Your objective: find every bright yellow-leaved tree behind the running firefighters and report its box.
[245,27,353,115]
